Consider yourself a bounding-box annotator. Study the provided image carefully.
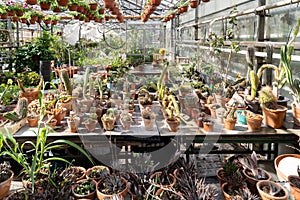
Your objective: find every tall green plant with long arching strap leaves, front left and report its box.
[0,82,93,193]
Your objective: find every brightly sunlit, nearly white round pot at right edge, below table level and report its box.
[274,154,300,181]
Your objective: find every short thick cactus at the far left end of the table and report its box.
[3,98,27,122]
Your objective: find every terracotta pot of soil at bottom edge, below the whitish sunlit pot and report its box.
[256,181,289,200]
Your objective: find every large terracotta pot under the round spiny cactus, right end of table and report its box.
[261,105,287,128]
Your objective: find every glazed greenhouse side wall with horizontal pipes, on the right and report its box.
[166,0,300,99]
